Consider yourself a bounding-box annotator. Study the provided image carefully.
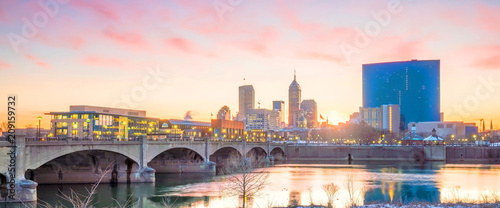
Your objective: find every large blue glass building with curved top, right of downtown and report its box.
[363,60,441,128]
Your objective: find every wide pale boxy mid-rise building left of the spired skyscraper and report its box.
[245,109,280,131]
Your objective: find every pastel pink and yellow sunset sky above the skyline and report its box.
[0,0,500,128]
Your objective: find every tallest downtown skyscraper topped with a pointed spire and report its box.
[288,74,302,127]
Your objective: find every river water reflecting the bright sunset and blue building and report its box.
[34,162,500,208]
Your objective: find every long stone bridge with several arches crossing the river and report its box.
[0,136,286,201]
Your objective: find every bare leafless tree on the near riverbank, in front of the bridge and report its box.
[222,151,269,208]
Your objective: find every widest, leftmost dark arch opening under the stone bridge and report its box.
[23,148,140,184]
